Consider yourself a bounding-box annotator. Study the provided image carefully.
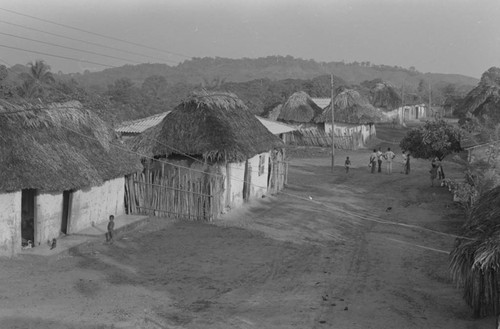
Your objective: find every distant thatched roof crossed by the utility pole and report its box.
[314,88,383,124]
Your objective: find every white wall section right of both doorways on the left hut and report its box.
[68,177,125,233]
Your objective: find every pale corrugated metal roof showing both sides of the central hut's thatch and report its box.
[115,111,297,135]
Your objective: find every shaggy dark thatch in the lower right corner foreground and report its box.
[450,187,500,317]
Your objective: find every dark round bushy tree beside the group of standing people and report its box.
[399,120,461,161]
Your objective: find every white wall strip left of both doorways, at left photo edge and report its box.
[0,191,21,257]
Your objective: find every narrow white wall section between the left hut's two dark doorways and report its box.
[35,193,63,247]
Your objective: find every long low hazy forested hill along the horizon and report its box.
[65,56,479,89]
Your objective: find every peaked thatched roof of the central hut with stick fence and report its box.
[127,91,283,162]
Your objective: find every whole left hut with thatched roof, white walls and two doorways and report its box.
[0,101,141,256]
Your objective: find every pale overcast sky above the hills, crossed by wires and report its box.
[0,0,500,78]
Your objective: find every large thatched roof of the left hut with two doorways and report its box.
[0,101,141,192]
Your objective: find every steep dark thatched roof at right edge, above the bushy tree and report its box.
[457,67,500,123]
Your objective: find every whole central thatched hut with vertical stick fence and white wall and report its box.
[127,91,285,221]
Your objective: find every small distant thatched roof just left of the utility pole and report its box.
[278,91,323,123]
